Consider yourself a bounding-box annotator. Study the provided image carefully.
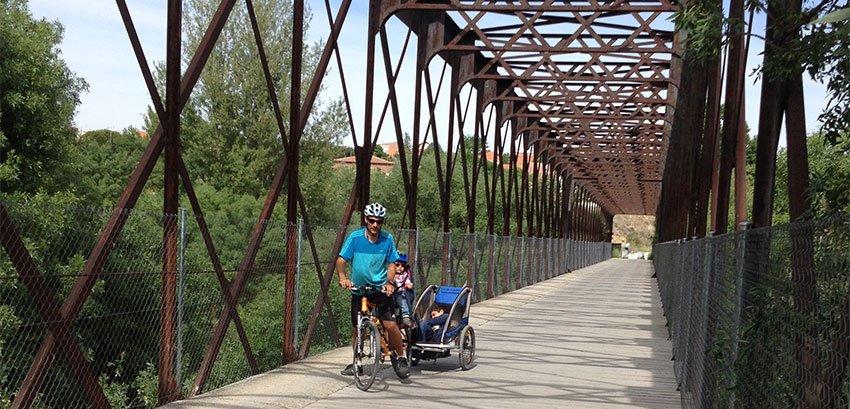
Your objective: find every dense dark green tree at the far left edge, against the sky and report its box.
[0,0,88,193]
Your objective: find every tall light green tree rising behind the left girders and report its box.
[146,0,347,196]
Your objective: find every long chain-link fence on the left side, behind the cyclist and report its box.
[0,204,611,408]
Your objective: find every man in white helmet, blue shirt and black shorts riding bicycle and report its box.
[336,203,410,377]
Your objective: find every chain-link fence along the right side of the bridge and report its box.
[654,217,850,408]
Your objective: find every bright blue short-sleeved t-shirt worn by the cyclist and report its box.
[339,227,398,287]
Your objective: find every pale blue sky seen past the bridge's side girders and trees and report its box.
[29,0,827,145]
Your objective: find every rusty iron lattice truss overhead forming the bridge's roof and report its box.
[384,0,678,215]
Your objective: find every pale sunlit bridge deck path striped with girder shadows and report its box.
[162,259,681,409]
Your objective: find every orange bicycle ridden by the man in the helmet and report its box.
[351,285,410,391]
